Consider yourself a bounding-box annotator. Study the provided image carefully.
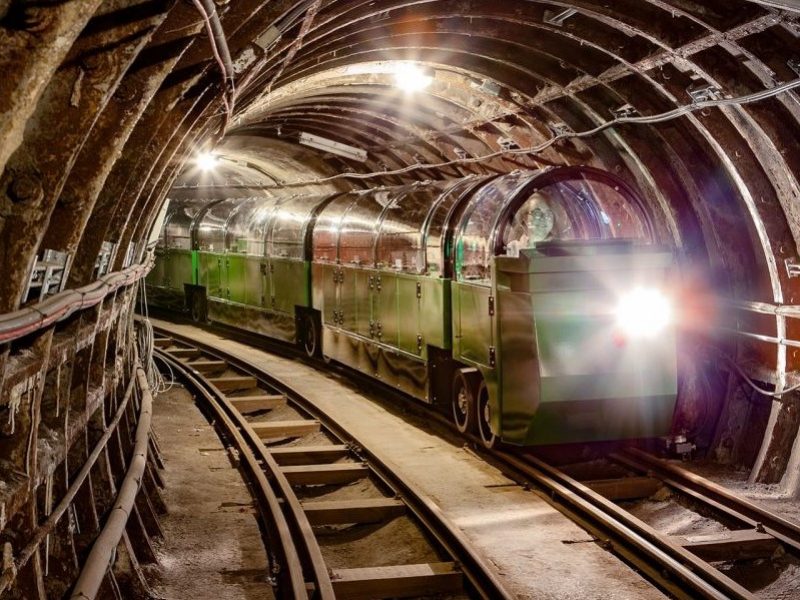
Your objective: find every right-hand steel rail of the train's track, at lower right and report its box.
[611,448,800,554]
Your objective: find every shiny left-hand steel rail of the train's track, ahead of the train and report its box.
[491,450,754,599]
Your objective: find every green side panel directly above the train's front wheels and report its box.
[451,282,494,367]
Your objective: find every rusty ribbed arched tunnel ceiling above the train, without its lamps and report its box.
[0,0,800,487]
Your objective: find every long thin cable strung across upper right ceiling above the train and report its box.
[252,78,800,189]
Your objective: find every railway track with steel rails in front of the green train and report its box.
[152,322,800,599]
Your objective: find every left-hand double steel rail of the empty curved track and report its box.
[155,349,335,600]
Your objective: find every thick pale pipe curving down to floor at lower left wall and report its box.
[70,363,153,600]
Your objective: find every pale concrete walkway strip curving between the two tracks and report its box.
[153,319,663,600]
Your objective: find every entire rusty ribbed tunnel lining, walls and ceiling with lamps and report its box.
[0,0,800,598]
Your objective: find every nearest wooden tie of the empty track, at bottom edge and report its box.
[331,562,464,599]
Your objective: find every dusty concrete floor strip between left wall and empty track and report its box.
[147,386,273,600]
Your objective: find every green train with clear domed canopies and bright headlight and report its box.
[146,166,678,447]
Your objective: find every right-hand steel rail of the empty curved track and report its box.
[153,326,514,600]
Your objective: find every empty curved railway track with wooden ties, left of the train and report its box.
[155,334,511,599]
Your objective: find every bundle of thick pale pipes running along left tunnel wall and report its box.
[0,255,155,344]
